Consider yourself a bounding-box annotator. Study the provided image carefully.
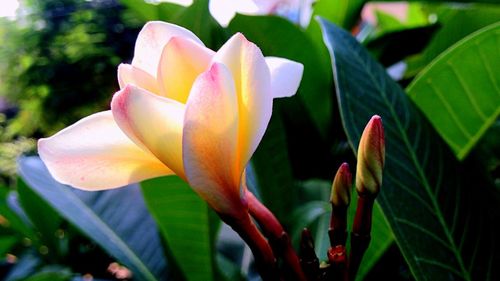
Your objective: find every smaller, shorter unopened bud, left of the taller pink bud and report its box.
[330,162,352,207]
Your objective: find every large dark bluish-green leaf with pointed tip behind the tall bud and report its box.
[321,20,500,280]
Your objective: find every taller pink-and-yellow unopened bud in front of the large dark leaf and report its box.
[356,115,385,195]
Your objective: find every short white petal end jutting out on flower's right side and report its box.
[266,57,304,98]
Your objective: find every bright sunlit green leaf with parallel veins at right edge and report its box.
[407,22,500,160]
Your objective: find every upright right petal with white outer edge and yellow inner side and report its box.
[214,33,273,171]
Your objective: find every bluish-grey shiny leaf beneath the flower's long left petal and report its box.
[19,157,166,280]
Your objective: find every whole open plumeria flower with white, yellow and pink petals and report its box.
[38,22,303,216]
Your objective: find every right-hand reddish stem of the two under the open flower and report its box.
[246,190,307,281]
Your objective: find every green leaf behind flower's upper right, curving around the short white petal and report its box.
[228,14,333,137]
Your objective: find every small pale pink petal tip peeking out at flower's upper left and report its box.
[118,63,160,94]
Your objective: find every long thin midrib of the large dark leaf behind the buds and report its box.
[338,32,471,280]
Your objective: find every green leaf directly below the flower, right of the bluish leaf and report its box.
[141,176,218,281]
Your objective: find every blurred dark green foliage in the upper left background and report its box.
[0,0,137,137]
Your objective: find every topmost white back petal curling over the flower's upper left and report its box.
[132,21,203,76]
